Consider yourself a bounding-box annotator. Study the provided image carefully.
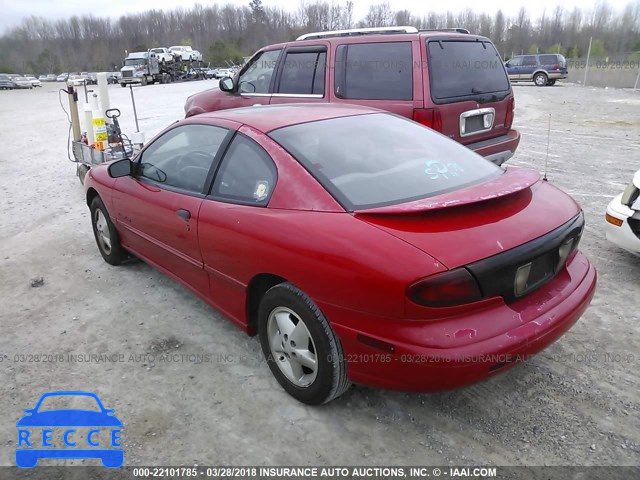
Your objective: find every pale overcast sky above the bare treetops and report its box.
[0,0,630,34]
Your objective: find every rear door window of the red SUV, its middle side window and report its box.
[276,51,327,95]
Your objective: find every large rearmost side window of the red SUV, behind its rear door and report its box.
[336,42,413,100]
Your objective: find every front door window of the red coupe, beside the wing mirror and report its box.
[139,125,228,193]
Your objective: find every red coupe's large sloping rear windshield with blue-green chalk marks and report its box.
[269,113,502,210]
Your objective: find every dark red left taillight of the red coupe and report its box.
[407,268,482,307]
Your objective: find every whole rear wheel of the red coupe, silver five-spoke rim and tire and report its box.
[258,282,350,405]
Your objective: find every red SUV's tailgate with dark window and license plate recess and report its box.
[424,36,512,145]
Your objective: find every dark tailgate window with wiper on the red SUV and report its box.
[427,40,510,103]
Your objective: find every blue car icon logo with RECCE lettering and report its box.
[16,392,124,468]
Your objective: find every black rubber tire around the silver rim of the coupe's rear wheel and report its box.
[258,282,350,405]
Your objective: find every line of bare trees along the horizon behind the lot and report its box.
[0,0,640,74]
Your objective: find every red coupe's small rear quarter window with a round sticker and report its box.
[211,134,277,206]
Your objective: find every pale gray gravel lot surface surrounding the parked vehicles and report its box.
[0,81,640,465]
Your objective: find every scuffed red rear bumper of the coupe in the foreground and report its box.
[321,252,597,391]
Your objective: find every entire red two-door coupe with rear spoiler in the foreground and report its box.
[85,105,596,404]
